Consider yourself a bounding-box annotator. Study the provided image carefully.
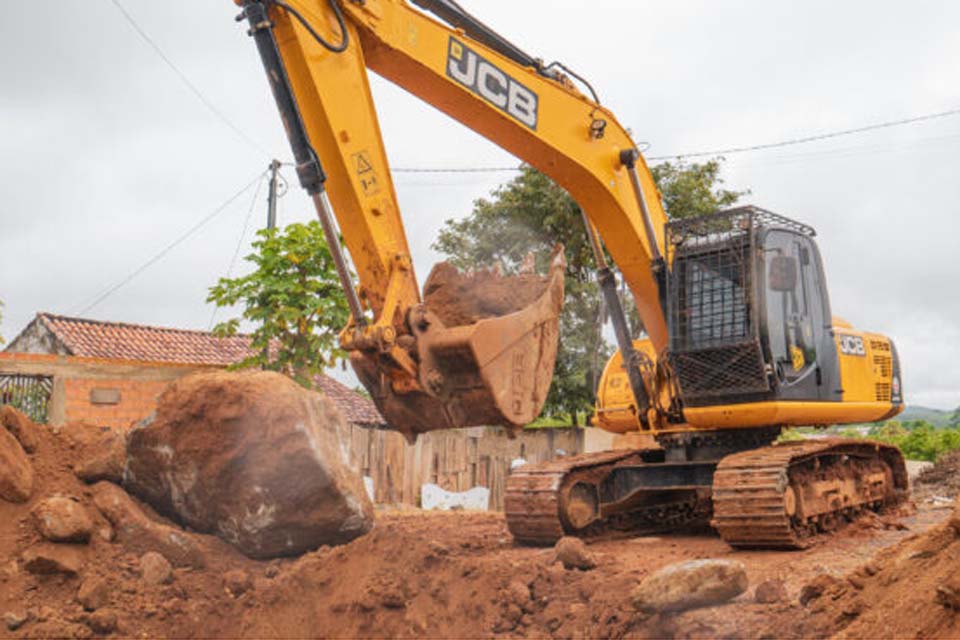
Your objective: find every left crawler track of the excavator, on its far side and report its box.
[504,450,709,545]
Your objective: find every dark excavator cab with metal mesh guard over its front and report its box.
[667,207,842,407]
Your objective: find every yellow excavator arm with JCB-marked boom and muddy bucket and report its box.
[238,0,667,435]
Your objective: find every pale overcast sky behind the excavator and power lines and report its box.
[0,0,960,408]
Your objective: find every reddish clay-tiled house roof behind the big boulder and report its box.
[10,313,384,425]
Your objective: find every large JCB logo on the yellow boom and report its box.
[447,38,540,131]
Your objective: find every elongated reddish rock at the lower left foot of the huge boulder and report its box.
[93,482,206,569]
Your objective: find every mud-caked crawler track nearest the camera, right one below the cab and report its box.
[712,439,907,549]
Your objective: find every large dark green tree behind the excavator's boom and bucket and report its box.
[433,158,746,425]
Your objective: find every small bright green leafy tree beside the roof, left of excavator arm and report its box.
[207,221,350,386]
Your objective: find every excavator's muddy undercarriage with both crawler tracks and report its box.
[505,430,907,549]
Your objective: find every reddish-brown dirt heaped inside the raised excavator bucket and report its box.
[423,262,549,327]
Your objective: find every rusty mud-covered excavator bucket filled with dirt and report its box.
[351,247,565,440]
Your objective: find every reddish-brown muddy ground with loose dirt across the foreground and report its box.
[0,410,960,638]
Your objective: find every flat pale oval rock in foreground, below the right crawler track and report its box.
[631,560,748,613]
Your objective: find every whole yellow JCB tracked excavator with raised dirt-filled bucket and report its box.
[235,0,908,549]
